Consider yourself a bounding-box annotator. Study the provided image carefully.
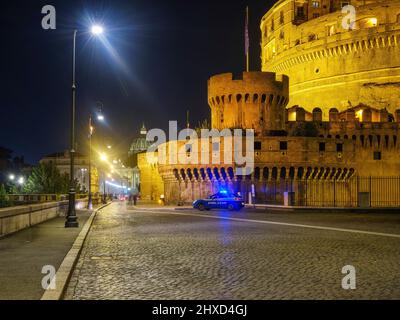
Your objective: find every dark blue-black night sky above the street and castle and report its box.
[0,0,274,163]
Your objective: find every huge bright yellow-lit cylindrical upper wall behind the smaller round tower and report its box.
[261,0,400,119]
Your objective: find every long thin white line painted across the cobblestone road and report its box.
[139,209,400,238]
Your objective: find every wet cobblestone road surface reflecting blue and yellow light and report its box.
[65,203,400,299]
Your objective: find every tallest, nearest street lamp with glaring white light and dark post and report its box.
[65,25,104,228]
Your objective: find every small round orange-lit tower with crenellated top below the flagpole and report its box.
[208,72,289,134]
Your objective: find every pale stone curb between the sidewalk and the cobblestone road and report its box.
[40,203,111,300]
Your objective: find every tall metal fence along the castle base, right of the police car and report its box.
[248,177,400,208]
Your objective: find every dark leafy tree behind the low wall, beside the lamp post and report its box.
[23,163,81,194]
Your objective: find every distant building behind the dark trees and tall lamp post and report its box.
[39,151,99,193]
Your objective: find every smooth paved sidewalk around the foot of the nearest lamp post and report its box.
[0,210,91,300]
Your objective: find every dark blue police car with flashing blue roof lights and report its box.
[193,191,244,211]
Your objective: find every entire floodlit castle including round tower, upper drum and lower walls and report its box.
[139,0,400,207]
